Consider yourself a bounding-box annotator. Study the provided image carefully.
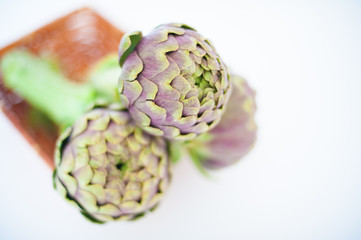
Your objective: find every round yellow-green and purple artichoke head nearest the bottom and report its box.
[54,103,170,222]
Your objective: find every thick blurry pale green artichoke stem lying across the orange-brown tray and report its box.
[1,50,95,127]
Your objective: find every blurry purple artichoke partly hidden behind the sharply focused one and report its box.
[186,75,257,169]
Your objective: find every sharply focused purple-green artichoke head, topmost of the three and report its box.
[119,23,230,140]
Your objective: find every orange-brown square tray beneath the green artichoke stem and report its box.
[0,8,124,168]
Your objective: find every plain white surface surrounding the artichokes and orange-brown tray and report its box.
[0,0,361,240]
